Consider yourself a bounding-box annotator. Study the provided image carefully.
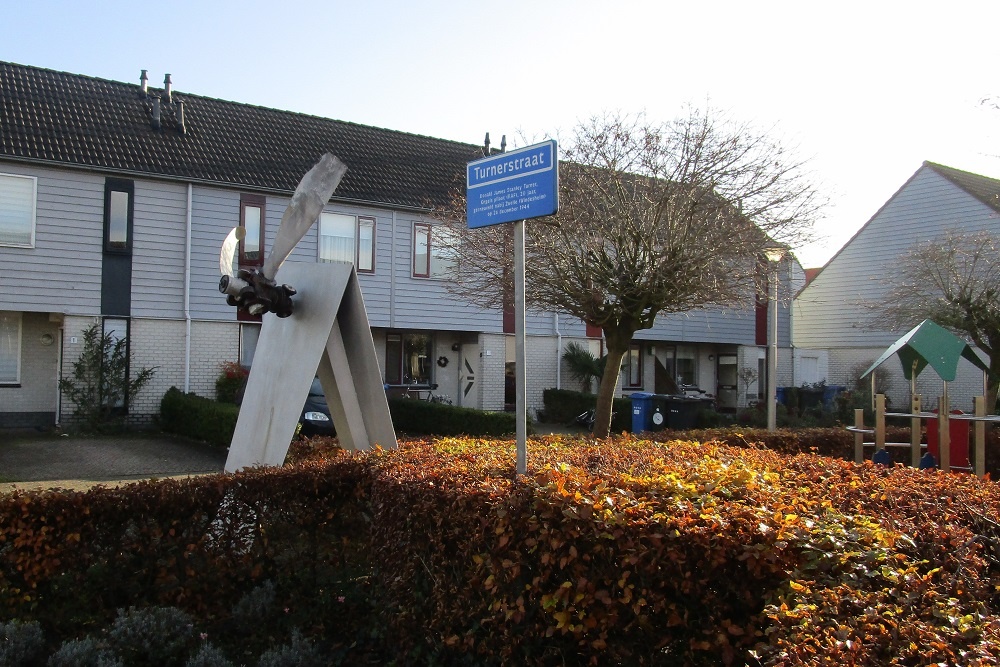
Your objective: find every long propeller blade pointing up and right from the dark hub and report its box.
[260,153,347,280]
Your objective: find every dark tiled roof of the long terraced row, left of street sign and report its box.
[0,62,482,208]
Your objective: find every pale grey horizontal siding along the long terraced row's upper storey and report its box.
[0,163,787,352]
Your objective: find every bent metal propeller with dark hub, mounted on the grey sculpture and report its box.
[219,153,347,317]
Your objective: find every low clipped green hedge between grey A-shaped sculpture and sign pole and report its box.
[389,398,516,435]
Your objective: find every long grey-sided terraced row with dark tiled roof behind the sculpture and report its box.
[0,63,796,427]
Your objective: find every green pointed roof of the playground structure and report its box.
[861,320,990,382]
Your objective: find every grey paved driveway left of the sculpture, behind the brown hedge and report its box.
[0,430,226,492]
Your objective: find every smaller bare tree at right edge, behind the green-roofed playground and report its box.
[869,231,1000,409]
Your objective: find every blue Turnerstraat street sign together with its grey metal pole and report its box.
[465,141,559,475]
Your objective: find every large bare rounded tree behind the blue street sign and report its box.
[441,110,823,437]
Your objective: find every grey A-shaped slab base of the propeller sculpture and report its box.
[226,262,396,472]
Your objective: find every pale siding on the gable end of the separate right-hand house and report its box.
[793,167,997,348]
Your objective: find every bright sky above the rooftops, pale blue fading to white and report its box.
[0,0,1000,266]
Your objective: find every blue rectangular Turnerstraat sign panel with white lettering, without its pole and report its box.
[465,141,559,228]
